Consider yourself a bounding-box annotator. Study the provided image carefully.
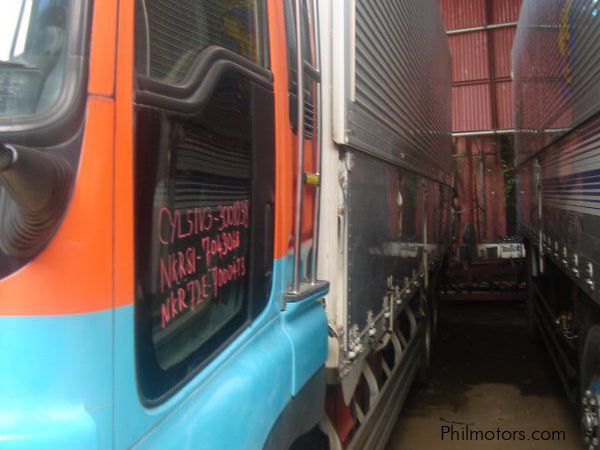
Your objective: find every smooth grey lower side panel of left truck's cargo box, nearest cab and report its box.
[347,152,426,330]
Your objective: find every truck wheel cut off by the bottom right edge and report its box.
[580,325,600,450]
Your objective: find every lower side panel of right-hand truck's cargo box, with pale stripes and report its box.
[518,116,600,299]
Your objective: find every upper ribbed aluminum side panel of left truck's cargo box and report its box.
[334,0,451,180]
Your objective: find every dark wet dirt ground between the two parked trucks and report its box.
[387,302,586,450]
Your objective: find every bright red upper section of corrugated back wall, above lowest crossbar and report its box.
[440,0,521,132]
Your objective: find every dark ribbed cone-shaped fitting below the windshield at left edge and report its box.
[0,144,73,258]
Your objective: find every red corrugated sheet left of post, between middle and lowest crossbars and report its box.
[452,83,492,131]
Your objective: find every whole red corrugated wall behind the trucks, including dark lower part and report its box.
[440,0,522,242]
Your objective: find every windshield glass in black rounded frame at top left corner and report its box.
[0,0,71,118]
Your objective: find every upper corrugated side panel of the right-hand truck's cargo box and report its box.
[512,0,600,163]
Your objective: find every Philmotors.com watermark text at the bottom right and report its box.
[440,424,567,442]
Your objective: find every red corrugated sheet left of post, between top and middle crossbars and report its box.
[449,31,490,83]
